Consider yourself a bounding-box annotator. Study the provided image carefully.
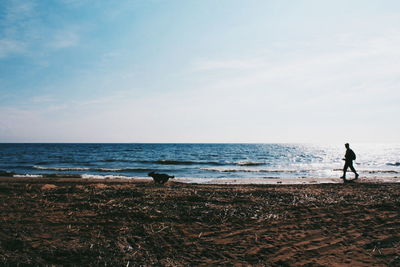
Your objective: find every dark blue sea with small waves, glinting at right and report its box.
[0,143,400,183]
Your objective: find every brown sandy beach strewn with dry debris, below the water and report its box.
[0,178,400,266]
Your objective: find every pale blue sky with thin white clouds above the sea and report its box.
[0,0,400,143]
